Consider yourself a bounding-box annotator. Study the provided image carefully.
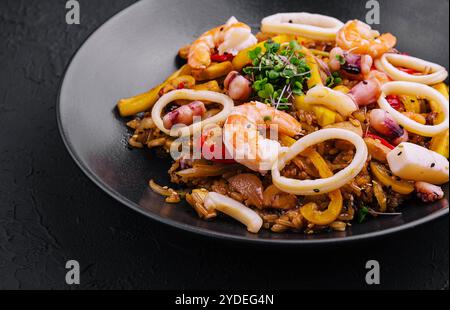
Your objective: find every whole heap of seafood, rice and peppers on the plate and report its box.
[118,13,449,234]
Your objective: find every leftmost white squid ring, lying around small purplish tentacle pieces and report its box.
[152,89,234,137]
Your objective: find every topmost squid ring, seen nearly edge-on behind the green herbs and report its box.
[261,13,344,41]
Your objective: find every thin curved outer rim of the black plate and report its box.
[56,0,449,246]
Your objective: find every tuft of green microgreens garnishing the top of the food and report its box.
[243,40,311,110]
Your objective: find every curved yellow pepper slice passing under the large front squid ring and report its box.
[300,149,344,226]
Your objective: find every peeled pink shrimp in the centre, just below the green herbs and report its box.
[223,102,302,173]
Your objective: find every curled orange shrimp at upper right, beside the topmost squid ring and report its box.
[336,20,397,59]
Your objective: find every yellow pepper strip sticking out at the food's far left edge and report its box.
[117,65,191,117]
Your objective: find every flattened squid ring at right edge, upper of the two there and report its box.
[375,53,448,85]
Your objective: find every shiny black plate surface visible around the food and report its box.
[58,0,449,244]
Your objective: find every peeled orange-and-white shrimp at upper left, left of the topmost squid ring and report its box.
[188,17,258,69]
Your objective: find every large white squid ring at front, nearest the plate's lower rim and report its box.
[272,128,368,196]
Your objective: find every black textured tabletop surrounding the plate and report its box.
[0,0,449,289]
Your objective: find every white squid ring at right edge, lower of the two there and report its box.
[378,82,449,137]
